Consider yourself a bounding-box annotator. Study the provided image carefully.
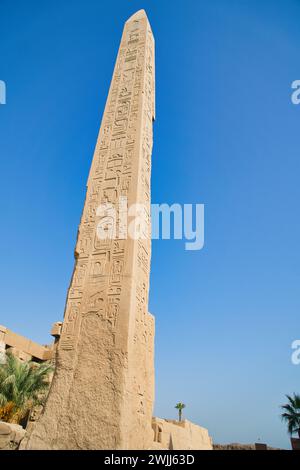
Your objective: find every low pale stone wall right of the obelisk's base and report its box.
[152,418,213,450]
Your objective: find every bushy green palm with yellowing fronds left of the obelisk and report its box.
[0,354,53,423]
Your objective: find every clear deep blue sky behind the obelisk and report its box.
[0,0,300,447]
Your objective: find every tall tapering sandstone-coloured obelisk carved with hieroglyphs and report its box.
[22,10,155,449]
